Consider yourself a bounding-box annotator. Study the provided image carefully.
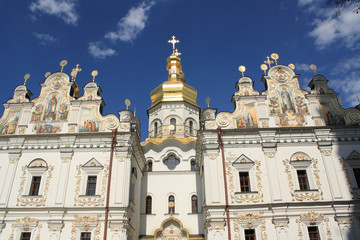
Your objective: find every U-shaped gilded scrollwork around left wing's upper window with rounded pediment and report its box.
[16,165,55,207]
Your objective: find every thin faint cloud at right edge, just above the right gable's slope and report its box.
[329,71,360,107]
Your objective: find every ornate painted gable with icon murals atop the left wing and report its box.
[0,72,122,135]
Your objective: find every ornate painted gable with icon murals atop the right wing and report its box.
[201,56,360,129]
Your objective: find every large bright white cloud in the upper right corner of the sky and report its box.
[309,4,360,50]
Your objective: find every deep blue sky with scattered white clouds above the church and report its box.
[0,0,360,139]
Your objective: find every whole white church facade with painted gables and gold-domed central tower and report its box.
[0,37,360,240]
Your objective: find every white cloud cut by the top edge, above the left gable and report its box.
[30,0,79,25]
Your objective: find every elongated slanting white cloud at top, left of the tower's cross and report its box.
[105,1,155,42]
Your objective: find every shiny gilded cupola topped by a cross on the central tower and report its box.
[150,36,197,108]
